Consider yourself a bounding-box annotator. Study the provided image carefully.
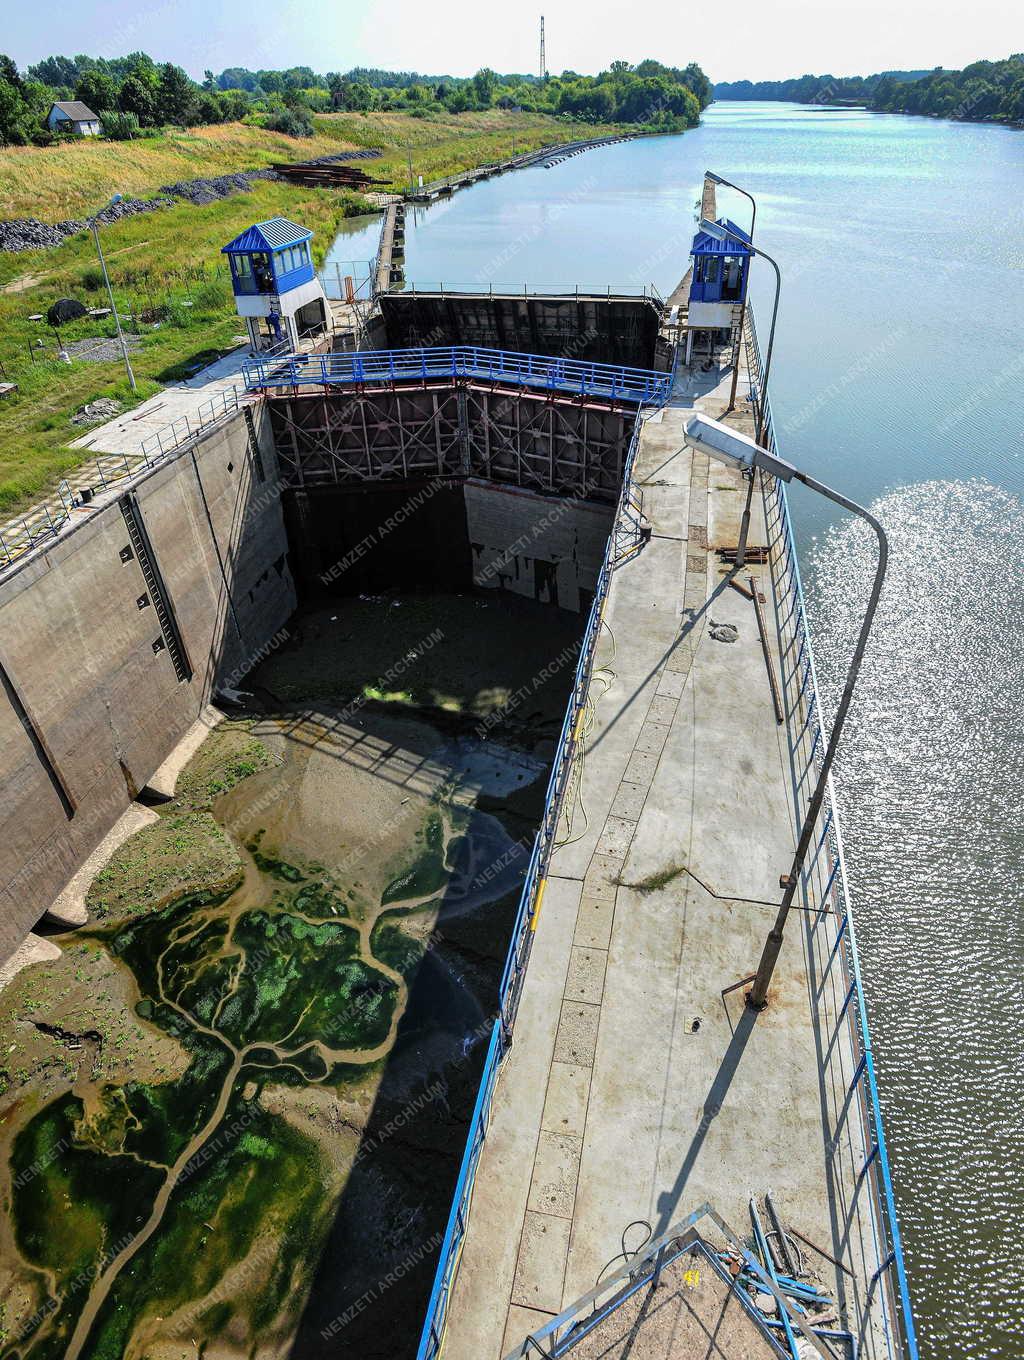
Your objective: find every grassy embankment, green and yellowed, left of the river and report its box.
[0,110,617,517]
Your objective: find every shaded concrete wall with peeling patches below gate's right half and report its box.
[465,479,615,612]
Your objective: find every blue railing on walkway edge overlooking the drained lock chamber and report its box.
[416,397,643,1360]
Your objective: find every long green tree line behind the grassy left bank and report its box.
[0,52,711,146]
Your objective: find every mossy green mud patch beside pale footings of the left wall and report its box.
[86,812,242,921]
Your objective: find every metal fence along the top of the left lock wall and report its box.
[0,386,245,573]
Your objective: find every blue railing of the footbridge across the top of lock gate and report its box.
[242,345,672,405]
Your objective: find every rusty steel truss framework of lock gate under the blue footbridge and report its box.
[267,378,636,505]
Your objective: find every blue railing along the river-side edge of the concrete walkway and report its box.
[747,313,918,1360]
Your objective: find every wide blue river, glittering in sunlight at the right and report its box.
[337,103,1024,1360]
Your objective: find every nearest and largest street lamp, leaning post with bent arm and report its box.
[683,413,889,1010]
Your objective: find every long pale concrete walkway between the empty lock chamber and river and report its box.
[443,359,874,1360]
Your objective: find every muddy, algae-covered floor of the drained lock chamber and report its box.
[0,596,579,1360]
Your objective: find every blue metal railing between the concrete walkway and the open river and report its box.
[747,309,918,1360]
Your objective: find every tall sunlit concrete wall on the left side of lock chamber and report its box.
[0,405,295,957]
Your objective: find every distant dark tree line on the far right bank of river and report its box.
[714,53,1024,124]
